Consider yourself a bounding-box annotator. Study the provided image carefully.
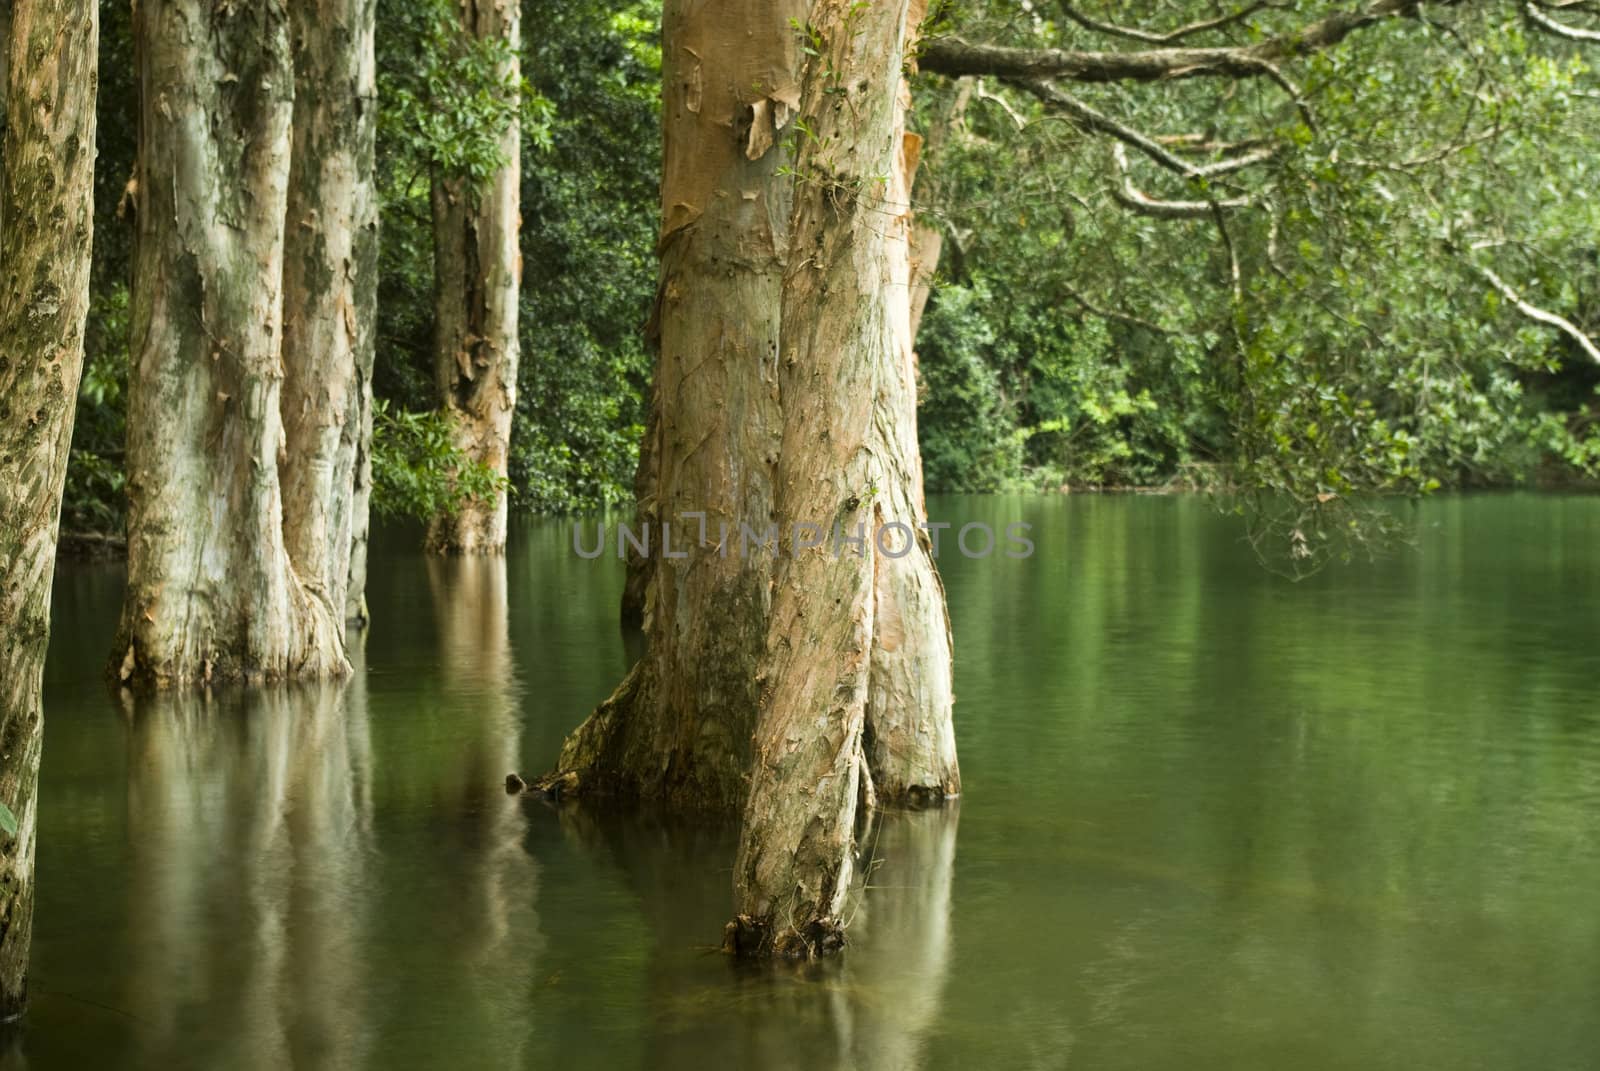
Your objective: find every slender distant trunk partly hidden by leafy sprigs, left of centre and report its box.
[427,0,522,554]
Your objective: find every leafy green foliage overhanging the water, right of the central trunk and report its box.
[917,0,1600,560]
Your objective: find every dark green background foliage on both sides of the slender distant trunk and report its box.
[373,0,661,511]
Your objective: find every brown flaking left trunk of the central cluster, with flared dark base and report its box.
[547,0,810,812]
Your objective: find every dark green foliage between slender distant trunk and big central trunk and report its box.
[510,0,661,511]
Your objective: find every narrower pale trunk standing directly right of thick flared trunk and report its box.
[278,0,378,621]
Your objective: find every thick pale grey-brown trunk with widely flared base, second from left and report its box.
[112,0,347,687]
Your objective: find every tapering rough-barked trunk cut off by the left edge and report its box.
[0,0,99,1021]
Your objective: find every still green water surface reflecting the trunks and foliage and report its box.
[5,496,1600,1071]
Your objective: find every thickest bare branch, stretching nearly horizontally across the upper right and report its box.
[917,0,1421,82]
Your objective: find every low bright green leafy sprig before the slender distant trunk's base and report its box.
[373,402,506,520]
